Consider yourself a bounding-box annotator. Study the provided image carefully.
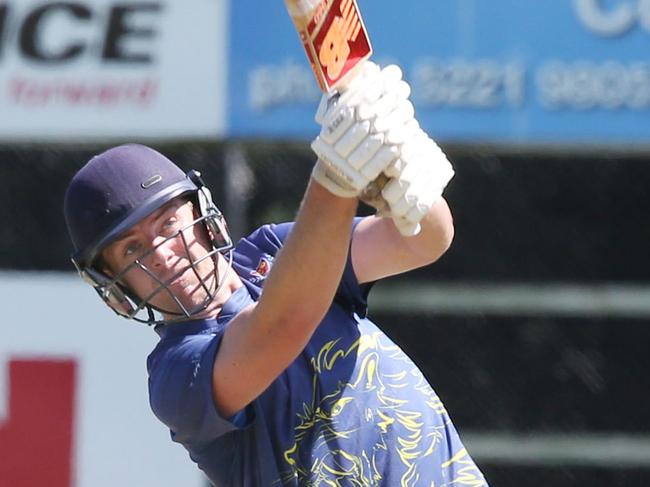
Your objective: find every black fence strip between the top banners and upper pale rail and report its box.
[5,142,650,282]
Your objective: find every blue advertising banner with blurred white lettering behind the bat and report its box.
[228,0,650,144]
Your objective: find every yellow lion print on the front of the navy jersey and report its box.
[280,332,486,487]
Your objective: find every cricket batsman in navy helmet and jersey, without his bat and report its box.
[64,62,487,487]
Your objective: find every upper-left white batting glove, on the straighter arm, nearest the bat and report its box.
[311,62,413,197]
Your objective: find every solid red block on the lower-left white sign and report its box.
[0,360,76,487]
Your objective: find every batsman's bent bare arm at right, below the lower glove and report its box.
[351,198,454,283]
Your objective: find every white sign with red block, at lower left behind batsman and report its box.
[0,272,208,487]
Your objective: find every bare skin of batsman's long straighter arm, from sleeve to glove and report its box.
[213,180,357,417]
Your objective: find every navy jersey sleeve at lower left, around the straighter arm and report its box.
[149,333,252,445]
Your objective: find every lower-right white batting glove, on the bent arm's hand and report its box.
[381,127,454,236]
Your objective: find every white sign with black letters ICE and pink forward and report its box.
[0,0,229,141]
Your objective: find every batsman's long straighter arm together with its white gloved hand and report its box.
[213,63,404,416]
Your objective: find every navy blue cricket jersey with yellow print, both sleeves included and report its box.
[147,224,487,487]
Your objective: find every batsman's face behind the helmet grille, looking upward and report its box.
[102,200,219,314]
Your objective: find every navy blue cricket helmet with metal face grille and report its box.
[64,144,232,324]
